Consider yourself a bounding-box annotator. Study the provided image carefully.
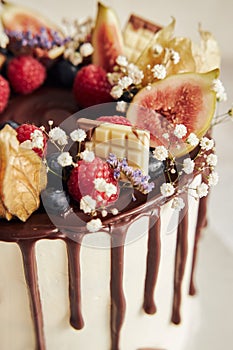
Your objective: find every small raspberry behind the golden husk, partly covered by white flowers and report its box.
[16,124,47,157]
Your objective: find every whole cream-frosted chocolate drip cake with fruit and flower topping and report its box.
[0,0,230,350]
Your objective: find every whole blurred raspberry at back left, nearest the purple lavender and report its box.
[7,56,46,95]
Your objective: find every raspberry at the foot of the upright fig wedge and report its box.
[73,64,112,108]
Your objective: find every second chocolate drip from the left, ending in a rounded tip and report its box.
[66,237,84,329]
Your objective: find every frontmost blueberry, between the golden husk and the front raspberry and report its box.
[41,187,70,215]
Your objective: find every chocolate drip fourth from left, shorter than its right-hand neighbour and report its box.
[143,209,161,315]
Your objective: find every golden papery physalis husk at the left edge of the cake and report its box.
[0,125,47,221]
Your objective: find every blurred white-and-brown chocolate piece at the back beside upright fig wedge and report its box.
[123,15,161,63]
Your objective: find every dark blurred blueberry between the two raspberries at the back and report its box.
[49,59,79,88]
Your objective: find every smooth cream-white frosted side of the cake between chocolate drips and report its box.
[1,178,200,350]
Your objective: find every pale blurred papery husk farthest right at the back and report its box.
[192,25,221,73]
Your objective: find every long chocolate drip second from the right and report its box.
[171,194,188,324]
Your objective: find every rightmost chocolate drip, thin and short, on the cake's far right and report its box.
[189,197,208,295]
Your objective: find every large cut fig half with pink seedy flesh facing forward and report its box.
[127,69,219,157]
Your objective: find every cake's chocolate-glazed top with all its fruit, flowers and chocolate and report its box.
[0,2,232,237]
